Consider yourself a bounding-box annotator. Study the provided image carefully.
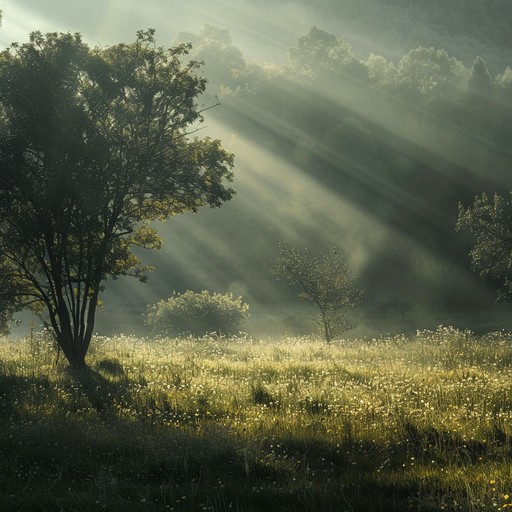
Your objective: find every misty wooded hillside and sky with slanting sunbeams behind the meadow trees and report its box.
[4,0,512,336]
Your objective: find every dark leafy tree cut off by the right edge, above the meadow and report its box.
[457,194,512,301]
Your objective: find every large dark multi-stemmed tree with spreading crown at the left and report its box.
[0,30,233,366]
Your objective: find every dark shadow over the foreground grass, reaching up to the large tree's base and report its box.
[0,359,510,512]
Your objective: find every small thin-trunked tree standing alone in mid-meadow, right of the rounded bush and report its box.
[271,243,362,341]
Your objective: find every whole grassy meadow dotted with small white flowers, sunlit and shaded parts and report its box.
[0,327,512,512]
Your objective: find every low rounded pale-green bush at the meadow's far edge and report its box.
[147,290,249,337]
